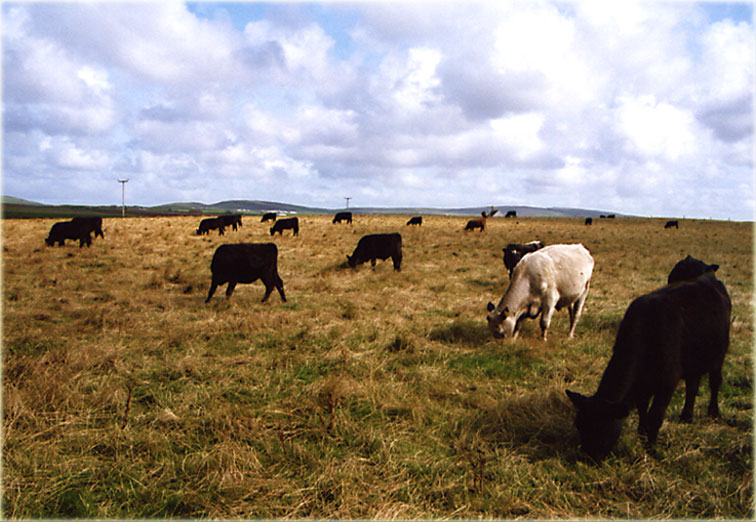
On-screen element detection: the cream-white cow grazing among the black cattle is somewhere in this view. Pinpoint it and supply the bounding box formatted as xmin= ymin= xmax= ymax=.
xmin=487 ymin=244 xmax=593 ymax=341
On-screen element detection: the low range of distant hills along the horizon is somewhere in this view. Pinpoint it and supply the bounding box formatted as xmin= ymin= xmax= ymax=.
xmin=2 ymin=196 xmax=619 ymax=218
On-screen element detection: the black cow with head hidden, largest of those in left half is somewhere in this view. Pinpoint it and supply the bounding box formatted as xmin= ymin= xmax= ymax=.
xmin=205 ymin=243 xmax=286 ymax=303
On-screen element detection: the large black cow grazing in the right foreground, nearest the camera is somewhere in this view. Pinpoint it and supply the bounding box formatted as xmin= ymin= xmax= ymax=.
xmin=567 ymin=264 xmax=731 ymax=461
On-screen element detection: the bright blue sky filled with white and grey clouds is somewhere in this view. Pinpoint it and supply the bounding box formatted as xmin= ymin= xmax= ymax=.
xmin=2 ymin=0 xmax=756 ymax=220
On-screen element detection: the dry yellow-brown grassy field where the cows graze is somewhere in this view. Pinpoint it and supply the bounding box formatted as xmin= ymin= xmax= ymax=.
xmin=2 ymin=212 xmax=754 ymax=519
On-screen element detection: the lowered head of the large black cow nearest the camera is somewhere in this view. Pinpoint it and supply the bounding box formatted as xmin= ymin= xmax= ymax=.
xmin=567 ymin=390 xmax=630 ymax=462
